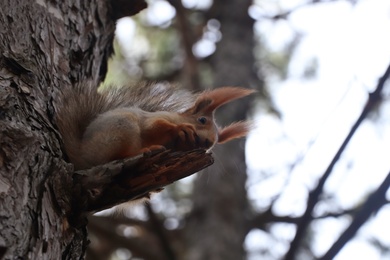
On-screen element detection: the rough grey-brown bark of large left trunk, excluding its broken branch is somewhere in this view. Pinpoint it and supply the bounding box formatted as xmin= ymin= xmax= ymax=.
xmin=0 ymin=1 xmax=114 ymax=259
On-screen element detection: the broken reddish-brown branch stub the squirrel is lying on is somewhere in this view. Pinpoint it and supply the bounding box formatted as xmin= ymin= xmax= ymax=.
xmin=69 ymin=149 xmax=214 ymax=226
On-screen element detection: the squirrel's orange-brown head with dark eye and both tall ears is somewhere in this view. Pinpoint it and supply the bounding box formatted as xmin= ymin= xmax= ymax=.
xmin=183 ymin=87 xmax=255 ymax=149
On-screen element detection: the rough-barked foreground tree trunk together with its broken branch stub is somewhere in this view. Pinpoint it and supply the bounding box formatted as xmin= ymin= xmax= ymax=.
xmin=0 ymin=0 xmax=212 ymax=259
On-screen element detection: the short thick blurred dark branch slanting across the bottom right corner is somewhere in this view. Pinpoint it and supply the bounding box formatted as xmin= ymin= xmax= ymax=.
xmin=320 ymin=172 xmax=390 ymax=260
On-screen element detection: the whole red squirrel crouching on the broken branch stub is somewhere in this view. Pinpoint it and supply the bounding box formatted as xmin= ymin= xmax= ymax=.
xmin=56 ymin=83 xmax=254 ymax=170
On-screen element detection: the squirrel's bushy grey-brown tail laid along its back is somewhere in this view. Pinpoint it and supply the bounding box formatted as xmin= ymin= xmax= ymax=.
xmin=55 ymin=80 xmax=196 ymax=169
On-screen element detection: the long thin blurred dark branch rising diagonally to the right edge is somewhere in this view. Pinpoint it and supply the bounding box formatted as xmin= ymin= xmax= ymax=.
xmin=285 ymin=65 xmax=390 ymax=260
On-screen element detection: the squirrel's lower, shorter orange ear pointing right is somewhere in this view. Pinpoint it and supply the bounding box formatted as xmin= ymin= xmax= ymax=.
xmin=218 ymin=121 xmax=254 ymax=144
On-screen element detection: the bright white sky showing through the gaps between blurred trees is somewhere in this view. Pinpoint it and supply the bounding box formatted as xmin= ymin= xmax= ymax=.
xmin=117 ymin=0 xmax=390 ymax=260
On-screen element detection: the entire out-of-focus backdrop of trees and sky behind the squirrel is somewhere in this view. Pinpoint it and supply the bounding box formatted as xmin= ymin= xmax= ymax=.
xmin=87 ymin=0 xmax=390 ymax=260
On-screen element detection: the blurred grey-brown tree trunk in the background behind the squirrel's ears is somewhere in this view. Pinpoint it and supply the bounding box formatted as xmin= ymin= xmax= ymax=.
xmin=187 ymin=0 xmax=262 ymax=260
